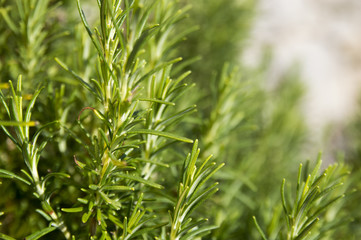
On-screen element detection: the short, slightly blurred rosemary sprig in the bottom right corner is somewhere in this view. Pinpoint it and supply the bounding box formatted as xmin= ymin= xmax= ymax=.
xmin=254 ymin=158 xmax=349 ymax=239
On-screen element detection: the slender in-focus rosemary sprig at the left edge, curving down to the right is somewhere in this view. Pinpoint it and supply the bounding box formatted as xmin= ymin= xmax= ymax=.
xmin=0 ymin=75 xmax=70 ymax=239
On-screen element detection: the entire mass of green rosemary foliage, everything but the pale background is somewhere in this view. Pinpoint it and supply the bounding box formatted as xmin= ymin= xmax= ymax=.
xmin=0 ymin=0 xmax=361 ymax=240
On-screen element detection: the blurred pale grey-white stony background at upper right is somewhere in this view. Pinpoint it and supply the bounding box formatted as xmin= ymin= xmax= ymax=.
xmin=242 ymin=0 xmax=361 ymax=154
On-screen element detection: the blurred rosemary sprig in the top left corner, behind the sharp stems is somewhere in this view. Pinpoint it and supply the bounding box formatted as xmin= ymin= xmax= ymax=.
xmin=0 ymin=0 xmax=64 ymax=83
